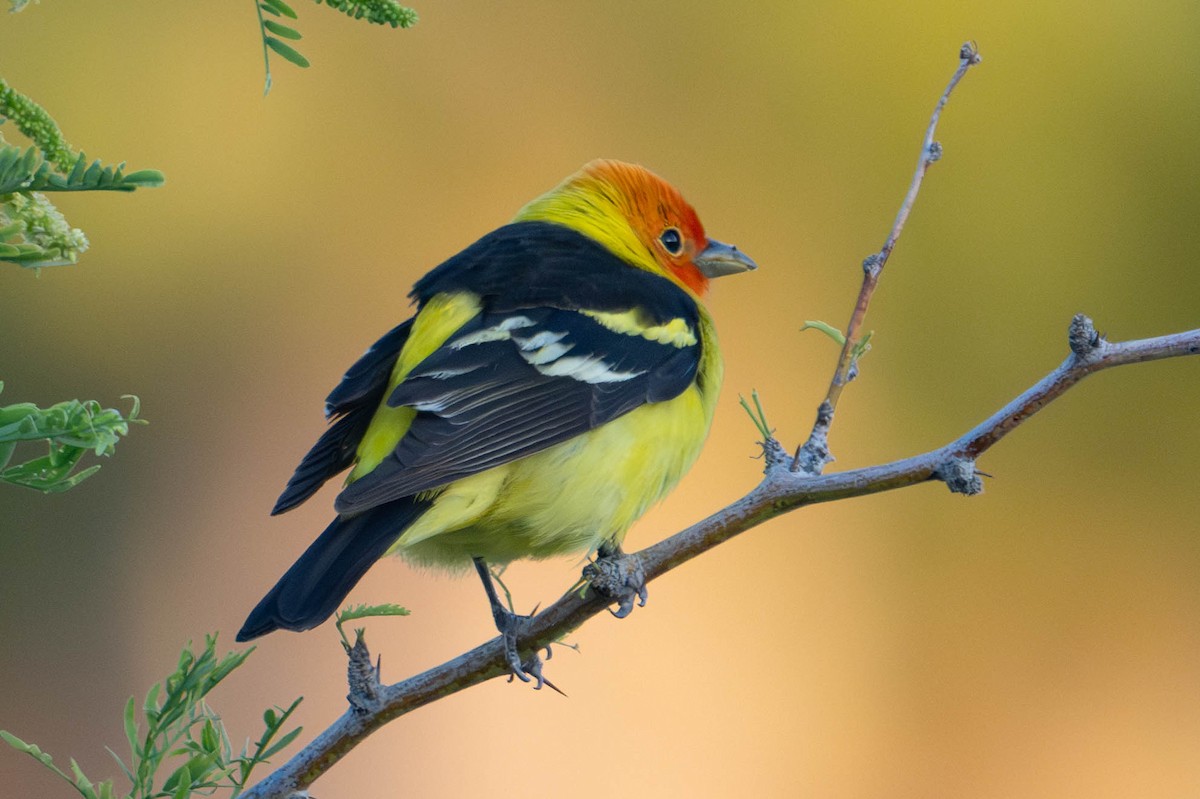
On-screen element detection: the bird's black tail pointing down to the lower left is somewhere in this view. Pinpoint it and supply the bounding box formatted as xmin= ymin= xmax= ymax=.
xmin=238 ymin=498 xmax=430 ymax=641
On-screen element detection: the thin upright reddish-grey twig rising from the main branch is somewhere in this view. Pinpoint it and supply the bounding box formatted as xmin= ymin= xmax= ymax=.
xmin=792 ymin=42 xmax=983 ymax=474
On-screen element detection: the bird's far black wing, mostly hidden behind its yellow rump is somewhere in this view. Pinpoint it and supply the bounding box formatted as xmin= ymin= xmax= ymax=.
xmin=271 ymin=319 xmax=413 ymax=516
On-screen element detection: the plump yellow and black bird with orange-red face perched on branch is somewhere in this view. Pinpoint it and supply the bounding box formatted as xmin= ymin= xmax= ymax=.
xmin=238 ymin=160 xmax=756 ymax=686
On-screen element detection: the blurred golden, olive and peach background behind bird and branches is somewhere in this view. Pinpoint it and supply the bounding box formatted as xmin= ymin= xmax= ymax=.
xmin=0 ymin=0 xmax=1200 ymax=799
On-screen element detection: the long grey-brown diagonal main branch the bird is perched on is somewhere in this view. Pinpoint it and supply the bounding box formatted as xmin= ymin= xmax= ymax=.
xmin=242 ymin=314 xmax=1200 ymax=799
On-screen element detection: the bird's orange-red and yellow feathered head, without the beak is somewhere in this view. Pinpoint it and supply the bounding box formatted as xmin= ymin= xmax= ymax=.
xmin=514 ymin=158 xmax=709 ymax=296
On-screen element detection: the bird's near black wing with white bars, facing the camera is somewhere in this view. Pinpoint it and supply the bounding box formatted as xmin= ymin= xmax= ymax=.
xmin=335 ymin=302 xmax=701 ymax=513
